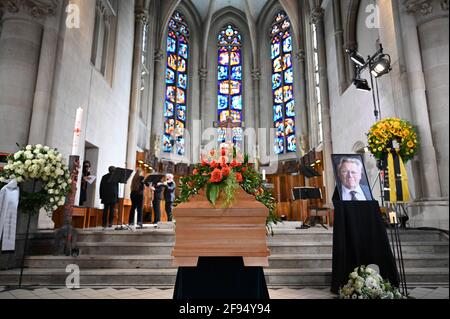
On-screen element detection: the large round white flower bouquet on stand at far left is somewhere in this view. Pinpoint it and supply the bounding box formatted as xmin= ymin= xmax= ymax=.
xmin=0 ymin=145 xmax=72 ymax=213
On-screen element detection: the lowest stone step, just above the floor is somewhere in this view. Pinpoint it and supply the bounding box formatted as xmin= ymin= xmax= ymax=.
xmin=0 ymin=268 xmax=448 ymax=287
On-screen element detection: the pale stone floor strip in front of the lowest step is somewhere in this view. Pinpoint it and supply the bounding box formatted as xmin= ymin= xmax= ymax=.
xmin=0 ymin=287 xmax=449 ymax=300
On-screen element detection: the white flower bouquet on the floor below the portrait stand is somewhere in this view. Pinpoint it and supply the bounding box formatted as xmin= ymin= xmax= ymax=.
xmin=339 ymin=266 xmax=405 ymax=299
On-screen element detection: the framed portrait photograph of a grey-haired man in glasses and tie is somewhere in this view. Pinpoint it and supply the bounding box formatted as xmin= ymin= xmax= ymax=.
xmin=331 ymin=154 xmax=374 ymax=201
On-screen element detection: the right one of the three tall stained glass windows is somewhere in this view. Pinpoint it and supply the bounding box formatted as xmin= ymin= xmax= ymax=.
xmin=270 ymin=11 xmax=297 ymax=155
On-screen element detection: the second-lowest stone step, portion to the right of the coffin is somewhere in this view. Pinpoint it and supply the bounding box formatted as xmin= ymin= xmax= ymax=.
xmin=269 ymin=254 xmax=449 ymax=269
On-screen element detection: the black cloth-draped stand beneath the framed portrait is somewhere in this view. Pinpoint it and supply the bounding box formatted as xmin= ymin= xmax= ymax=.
xmin=331 ymin=201 xmax=399 ymax=293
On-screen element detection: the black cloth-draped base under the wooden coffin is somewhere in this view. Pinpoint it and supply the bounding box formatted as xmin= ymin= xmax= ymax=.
xmin=173 ymin=257 xmax=270 ymax=300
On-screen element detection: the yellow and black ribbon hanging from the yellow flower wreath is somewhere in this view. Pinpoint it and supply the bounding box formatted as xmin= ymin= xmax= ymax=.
xmin=384 ymin=149 xmax=409 ymax=203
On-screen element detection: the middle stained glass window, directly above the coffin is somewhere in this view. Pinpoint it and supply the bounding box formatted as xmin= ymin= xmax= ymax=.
xmin=217 ymin=24 xmax=243 ymax=149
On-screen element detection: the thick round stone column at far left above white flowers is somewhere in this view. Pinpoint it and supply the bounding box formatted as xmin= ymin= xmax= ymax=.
xmin=0 ymin=0 xmax=57 ymax=152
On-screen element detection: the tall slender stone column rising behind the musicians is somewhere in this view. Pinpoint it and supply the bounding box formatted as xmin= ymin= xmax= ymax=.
xmin=127 ymin=7 xmax=148 ymax=180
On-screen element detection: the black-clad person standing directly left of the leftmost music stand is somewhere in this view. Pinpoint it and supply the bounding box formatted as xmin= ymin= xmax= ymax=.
xmin=100 ymin=166 xmax=119 ymax=228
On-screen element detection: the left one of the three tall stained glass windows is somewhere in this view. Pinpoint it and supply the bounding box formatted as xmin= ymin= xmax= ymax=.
xmin=163 ymin=11 xmax=189 ymax=155
